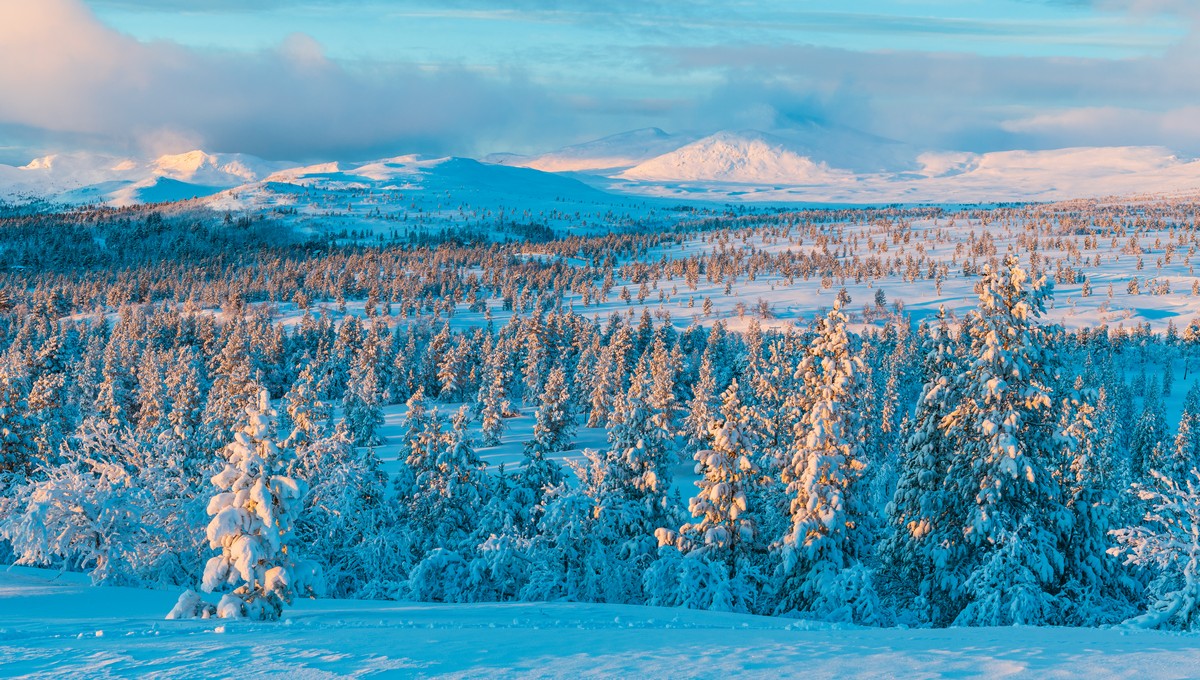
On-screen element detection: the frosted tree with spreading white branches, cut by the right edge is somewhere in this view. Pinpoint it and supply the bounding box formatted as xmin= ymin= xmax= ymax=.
xmin=1111 ymin=470 xmax=1200 ymax=631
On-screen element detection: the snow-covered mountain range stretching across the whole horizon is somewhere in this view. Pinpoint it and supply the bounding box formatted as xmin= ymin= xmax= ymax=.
xmin=0 ymin=124 xmax=1200 ymax=207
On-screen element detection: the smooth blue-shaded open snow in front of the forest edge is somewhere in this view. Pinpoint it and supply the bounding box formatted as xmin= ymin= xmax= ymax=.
xmin=0 ymin=567 xmax=1200 ymax=679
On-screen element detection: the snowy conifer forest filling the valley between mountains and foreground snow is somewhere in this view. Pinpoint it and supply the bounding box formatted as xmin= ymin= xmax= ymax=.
xmin=0 ymin=201 xmax=1200 ymax=630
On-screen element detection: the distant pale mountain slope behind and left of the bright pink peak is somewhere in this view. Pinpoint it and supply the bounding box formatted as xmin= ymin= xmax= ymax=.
xmin=484 ymin=127 xmax=696 ymax=173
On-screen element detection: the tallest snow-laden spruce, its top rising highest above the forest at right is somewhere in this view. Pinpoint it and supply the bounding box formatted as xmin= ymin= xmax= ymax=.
xmin=941 ymin=255 xmax=1070 ymax=626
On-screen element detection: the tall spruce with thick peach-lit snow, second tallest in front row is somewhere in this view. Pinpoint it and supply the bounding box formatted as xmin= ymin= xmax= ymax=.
xmin=775 ymin=305 xmax=881 ymax=624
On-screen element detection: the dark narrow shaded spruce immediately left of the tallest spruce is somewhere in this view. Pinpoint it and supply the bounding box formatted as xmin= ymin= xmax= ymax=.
xmin=882 ymin=308 xmax=967 ymax=626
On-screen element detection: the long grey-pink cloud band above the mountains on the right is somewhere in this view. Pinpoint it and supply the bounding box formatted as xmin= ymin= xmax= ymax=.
xmin=647 ymin=36 xmax=1200 ymax=152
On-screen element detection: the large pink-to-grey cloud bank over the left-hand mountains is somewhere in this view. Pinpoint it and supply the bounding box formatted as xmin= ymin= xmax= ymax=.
xmin=0 ymin=0 xmax=563 ymax=160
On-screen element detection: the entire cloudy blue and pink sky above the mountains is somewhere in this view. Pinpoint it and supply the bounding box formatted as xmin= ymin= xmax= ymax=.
xmin=0 ymin=0 xmax=1200 ymax=163
